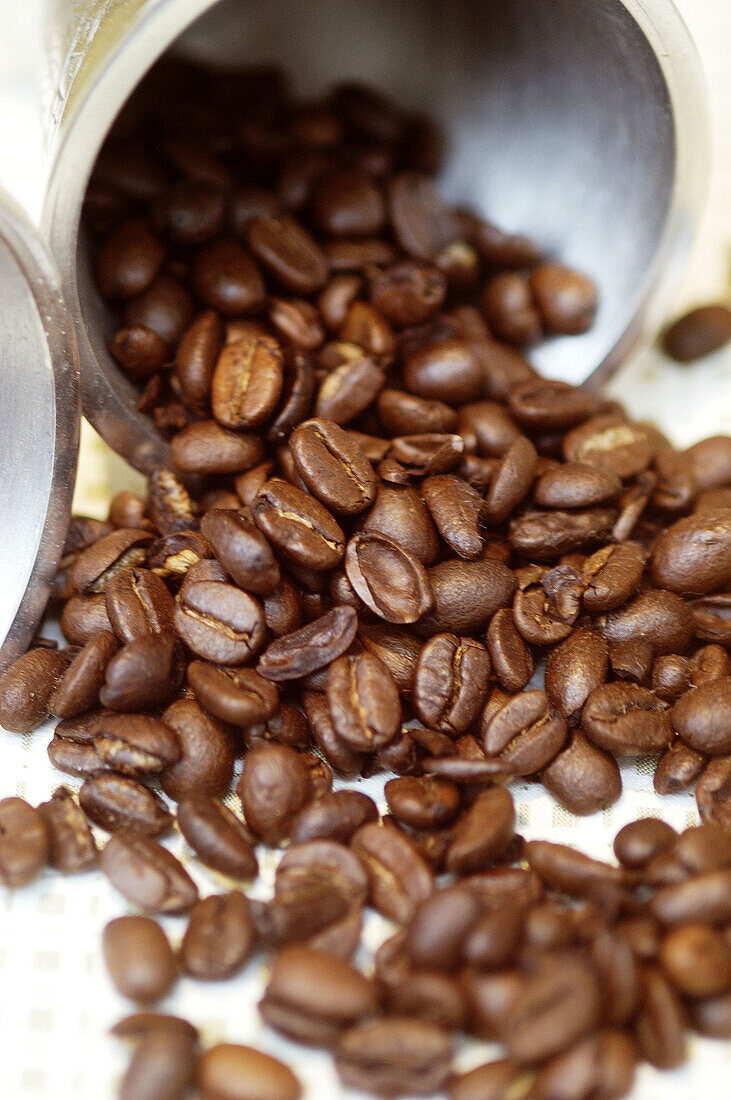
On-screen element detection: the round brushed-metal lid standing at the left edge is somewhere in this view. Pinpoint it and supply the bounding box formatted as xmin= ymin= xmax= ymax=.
xmin=0 ymin=193 xmax=80 ymax=672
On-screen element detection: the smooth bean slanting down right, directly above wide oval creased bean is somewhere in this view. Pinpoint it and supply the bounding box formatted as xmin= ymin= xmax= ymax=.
xmin=200 ymin=508 xmax=281 ymax=595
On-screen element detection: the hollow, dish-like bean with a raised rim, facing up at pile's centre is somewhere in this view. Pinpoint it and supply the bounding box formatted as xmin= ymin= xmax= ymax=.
xmin=345 ymin=531 xmax=432 ymax=624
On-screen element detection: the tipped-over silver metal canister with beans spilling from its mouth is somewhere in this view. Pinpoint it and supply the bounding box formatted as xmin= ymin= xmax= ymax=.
xmin=0 ymin=0 xmax=707 ymax=663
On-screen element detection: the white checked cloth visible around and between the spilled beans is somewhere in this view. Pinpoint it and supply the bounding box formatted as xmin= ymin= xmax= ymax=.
xmin=0 ymin=0 xmax=731 ymax=1100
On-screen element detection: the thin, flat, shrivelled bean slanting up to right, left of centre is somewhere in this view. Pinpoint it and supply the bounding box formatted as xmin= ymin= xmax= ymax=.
xmin=257 ymin=607 xmax=357 ymax=682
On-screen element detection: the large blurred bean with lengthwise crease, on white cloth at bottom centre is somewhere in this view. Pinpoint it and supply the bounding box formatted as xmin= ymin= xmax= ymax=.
xmin=259 ymin=947 xmax=377 ymax=1046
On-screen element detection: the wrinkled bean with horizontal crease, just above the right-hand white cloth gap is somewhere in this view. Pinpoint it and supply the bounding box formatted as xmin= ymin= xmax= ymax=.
xmin=582 ymin=683 xmax=673 ymax=756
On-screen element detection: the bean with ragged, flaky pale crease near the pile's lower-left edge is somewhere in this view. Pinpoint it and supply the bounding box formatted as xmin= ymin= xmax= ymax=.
xmin=93 ymin=713 xmax=180 ymax=777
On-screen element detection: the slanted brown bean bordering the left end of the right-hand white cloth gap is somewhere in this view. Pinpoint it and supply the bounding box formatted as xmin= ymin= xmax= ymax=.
xmin=446 ymin=787 xmax=516 ymax=875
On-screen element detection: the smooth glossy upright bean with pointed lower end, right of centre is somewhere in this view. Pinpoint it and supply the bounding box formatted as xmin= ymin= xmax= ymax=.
xmin=545 ymin=627 xmax=609 ymax=725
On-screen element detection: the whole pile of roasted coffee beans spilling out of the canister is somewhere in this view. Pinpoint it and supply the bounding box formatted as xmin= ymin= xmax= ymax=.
xmin=0 ymin=65 xmax=731 ymax=1100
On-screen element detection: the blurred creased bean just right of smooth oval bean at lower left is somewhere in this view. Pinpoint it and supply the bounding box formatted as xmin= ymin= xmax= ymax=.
xmin=180 ymin=890 xmax=255 ymax=981
